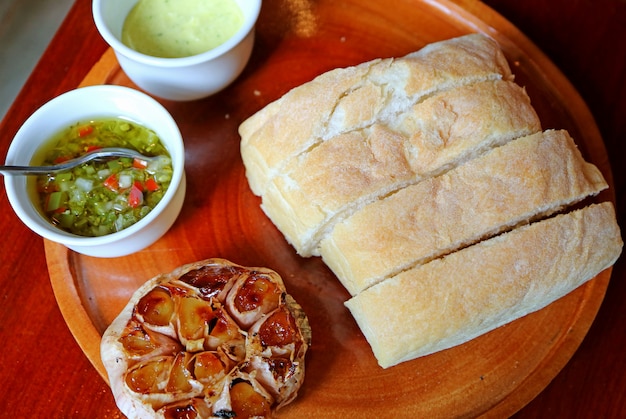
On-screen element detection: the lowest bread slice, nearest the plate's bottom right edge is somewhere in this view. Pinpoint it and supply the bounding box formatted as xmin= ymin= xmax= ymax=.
xmin=346 ymin=202 xmax=623 ymax=368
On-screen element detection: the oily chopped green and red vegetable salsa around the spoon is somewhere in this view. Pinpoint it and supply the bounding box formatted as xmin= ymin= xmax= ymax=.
xmin=36 ymin=119 xmax=172 ymax=237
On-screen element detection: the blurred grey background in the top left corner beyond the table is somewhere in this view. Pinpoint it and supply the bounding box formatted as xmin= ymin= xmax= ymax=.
xmin=0 ymin=0 xmax=74 ymax=120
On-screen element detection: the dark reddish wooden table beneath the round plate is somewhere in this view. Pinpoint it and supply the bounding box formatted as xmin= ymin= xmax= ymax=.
xmin=0 ymin=0 xmax=626 ymax=418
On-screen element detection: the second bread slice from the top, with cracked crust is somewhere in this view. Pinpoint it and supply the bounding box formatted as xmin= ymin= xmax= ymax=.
xmin=262 ymin=80 xmax=541 ymax=256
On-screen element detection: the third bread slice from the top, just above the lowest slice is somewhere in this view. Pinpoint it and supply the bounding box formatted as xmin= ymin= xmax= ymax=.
xmin=321 ymin=130 xmax=608 ymax=295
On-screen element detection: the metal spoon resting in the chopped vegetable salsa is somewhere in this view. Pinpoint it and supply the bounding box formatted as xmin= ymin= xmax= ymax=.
xmin=0 ymin=147 xmax=154 ymax=176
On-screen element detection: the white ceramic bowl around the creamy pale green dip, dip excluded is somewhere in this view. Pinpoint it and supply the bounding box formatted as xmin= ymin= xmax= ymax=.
xmin=92 ymin=0 xmax=261 ymax=101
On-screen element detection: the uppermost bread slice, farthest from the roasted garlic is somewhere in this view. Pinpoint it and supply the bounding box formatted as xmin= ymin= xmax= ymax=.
xmin=239 ymin=34 xmax=513 ymax=195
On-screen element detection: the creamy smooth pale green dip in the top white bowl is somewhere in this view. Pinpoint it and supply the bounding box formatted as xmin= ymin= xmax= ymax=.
xmin=122 ymin=0 xmax=243 ymax=58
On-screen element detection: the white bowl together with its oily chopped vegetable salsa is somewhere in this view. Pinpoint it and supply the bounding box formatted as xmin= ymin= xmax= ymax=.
xmin=5 ymin=86 xmax=186 ymax=257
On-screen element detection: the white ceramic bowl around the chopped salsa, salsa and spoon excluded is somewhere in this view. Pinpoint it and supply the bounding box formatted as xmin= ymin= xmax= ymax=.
xmin=5 ymin=86 xmax=186 ymax=257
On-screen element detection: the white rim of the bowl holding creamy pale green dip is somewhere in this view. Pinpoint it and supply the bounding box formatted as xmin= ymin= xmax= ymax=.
xmin=92 ymin=0 xmax=262 ymax=68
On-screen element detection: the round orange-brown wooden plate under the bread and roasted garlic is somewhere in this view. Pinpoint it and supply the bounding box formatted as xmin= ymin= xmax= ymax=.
xmin=45 ymin=0 xmax=613 ymax=418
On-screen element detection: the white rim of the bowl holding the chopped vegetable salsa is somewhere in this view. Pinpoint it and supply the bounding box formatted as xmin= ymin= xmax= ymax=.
xmin=5 ymin=85 xmax=185 ymax=247
